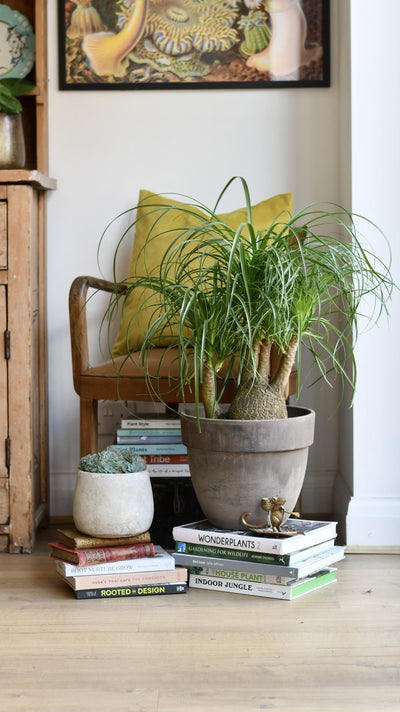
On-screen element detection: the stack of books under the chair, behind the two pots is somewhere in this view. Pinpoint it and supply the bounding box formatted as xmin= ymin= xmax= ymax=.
xmin=116 ymin=416 xmax=190 ymax=477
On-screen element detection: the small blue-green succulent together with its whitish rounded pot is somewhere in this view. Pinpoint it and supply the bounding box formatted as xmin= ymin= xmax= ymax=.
xmin=73 ymin=446 xmax=154 ymax=538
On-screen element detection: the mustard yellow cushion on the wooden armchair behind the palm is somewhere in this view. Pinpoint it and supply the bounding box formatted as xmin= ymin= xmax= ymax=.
xmin=113 ymin=190 xmax=293 ymax=357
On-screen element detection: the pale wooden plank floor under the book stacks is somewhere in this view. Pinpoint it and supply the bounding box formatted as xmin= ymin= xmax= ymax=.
xmin=0 ymin=531 xmax=400 ymax=712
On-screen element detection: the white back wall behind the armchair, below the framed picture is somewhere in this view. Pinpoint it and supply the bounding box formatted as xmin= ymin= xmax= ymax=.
xmin=48 ymin=0 xmax=396 ymax=532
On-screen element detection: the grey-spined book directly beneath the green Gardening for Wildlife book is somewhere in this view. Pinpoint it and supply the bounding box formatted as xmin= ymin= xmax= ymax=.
xmin=172 ymin=546 xmax=344 ymax=580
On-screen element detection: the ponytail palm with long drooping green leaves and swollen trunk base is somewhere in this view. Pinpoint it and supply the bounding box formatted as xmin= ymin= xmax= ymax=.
xmin=101 ymin=178 xmax=393 ymax=420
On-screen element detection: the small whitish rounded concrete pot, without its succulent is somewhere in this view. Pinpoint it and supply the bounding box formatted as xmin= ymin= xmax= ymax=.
xmin=72 ymin=470 xmax=154 ymax=538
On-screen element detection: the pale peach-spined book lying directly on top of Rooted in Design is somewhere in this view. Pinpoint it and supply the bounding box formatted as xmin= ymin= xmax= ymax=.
xmin=56 ymin=568 xmax=188 ymax=591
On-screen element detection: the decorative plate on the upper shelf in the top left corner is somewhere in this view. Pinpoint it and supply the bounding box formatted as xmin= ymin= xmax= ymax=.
xmin=0 ymin=5 xmax=35 ymax=79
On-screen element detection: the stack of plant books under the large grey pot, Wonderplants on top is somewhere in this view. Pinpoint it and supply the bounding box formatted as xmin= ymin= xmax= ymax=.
xmin=172 ymin=519 xmax=344 ymax=600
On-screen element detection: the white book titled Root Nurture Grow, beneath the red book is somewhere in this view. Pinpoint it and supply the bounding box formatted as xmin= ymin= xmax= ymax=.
xmin=53 ymin=544 xmax=175 ymax=576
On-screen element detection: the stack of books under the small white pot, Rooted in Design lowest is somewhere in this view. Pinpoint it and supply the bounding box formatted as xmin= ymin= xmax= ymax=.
xmin=49 ymin=527 xmax=187 ymax=599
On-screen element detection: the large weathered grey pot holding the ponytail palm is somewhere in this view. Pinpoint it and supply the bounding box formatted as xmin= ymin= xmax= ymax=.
xmin=181 ymin=406 xmax=315 ymax=530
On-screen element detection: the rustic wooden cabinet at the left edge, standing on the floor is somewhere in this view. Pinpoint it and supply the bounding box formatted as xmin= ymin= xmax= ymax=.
xmin=0 ymin=170 xmax=56 ymax=553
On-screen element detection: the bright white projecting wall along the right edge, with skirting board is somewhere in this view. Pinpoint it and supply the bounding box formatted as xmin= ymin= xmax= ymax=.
xmin=340 ymin=0 xmax=400 ymax=547
